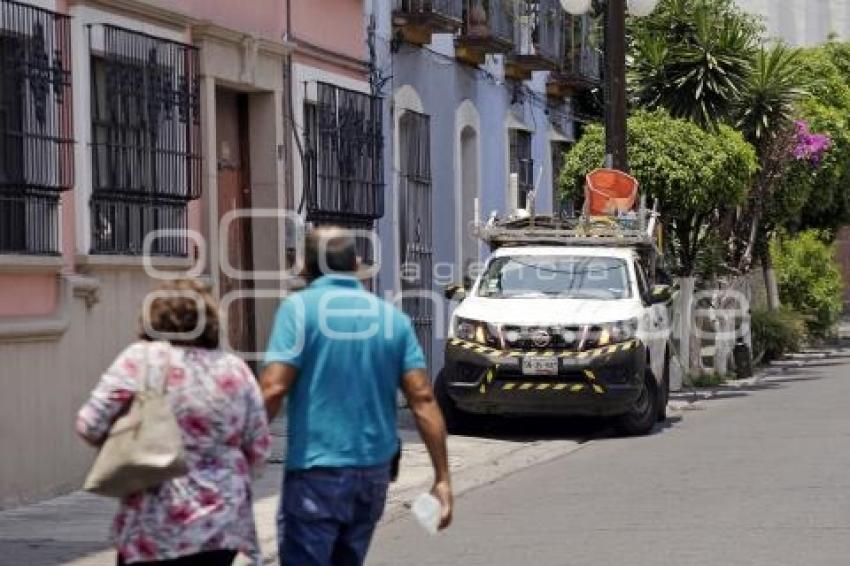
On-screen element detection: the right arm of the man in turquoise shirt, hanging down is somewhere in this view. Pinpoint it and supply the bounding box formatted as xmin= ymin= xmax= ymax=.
xmin=401 ymin=369 xmax=453 ymax=529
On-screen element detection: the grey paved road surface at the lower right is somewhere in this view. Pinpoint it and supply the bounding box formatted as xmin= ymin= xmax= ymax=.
xmin=369 ymin=352 xmax=850 ymax=566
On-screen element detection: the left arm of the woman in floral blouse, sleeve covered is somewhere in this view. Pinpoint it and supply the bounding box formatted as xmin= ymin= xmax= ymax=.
xmin=77 ymin=343 xmax=147 ymax=446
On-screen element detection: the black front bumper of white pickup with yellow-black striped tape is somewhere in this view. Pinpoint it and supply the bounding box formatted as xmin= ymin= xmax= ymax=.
xmin=442 ymin=339 xmax=646 ymax=416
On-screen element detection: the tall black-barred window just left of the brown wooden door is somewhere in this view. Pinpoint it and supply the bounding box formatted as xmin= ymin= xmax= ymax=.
xmin=90 ymin=25 xmax=201 ymax=256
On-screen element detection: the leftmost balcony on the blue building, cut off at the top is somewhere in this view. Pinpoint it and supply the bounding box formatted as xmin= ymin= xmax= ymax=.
xmin=393 ymin=0 xmax=463 ymax=45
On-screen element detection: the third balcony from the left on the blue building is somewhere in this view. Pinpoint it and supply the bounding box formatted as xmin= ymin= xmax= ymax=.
xmin=514 ymin=0 xmax=564 ymax=70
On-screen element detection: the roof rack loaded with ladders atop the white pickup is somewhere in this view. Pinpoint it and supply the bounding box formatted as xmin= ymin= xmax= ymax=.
xmin=473 ymin=199 xmax=660 ymax=251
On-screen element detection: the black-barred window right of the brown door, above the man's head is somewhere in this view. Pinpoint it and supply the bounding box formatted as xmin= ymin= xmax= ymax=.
xmin=303 ymin=83 xmax=384 ymax=221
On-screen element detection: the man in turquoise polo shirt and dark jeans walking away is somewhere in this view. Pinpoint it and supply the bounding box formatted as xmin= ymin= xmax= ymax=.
xmin=261 ymin=228 xmax=452 ymax=566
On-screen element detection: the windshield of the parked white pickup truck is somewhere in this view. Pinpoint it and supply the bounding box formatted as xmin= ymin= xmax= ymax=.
xmin=478 ymin=255 xmax=631 ymax=300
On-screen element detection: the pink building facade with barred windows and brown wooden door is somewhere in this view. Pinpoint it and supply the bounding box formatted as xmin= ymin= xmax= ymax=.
xmin=0 ymin=0 xmax=324 ymax=507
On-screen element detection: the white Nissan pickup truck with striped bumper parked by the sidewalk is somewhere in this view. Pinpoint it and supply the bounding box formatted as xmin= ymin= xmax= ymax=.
xmin=435 ymin=216 xmax=671 ymax=435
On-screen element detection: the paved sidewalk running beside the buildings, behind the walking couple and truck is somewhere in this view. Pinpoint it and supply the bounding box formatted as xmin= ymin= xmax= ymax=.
xmin=0 ymin=346 xmax=850 ymax=566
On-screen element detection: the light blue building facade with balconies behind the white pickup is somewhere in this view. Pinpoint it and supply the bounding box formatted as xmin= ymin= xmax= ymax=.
xmin=367 ymin=0 xmax=598 ymax=373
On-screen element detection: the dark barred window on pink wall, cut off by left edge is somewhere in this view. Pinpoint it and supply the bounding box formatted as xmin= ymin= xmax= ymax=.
xmin=0 ymin=0 xmax=74 ymax=255
